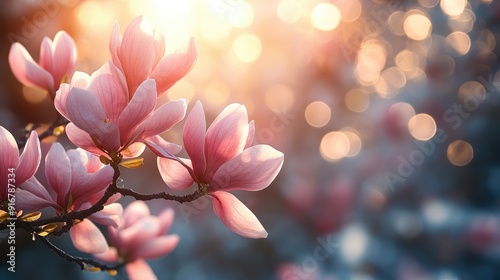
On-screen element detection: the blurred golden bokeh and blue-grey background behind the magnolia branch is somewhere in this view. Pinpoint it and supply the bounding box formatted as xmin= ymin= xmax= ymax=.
xmin=0 ymin=0 xmax=500 ymax=280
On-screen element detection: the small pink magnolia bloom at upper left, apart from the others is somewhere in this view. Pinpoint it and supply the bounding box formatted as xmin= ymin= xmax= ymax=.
xmin=9 ymin=31 xmax=76 ymax=99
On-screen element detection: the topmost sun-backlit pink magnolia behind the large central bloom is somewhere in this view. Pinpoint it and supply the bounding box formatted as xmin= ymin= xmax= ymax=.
xmin=109 ymin=16 xmax=198 ymax=95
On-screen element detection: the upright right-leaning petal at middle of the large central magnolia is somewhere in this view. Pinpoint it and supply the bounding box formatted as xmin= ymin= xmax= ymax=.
xmin=118 ymin=79 xmax=156 ymax=144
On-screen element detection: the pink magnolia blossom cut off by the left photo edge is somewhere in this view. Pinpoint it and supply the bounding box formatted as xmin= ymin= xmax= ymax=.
xmin=0 ymin=126 xmax=41 ymax=201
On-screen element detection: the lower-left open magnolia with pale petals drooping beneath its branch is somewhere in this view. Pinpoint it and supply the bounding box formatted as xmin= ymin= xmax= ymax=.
xmin=16 ymin=143 xmax=123 ymax=253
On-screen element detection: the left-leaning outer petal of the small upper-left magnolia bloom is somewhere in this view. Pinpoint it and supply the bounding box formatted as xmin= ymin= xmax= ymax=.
xmin=9 ymin=42 xmax=54 ymax=92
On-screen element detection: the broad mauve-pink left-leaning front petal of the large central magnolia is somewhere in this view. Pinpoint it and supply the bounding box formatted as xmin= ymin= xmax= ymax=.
xmin=66 ymin=88 xmax=120 ymax=152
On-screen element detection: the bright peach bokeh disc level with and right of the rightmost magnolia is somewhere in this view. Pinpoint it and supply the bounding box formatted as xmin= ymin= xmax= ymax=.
xmin=319 ymin=131 xmax=351 ymax=162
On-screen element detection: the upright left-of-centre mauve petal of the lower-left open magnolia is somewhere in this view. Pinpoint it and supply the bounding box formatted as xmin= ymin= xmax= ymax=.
xmin=45 ymin=142 xmax=71 ymax=208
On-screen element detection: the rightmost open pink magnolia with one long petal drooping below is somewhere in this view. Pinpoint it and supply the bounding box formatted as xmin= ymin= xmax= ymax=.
xmin=158 ymin=102 xmax=283 ymax=238
